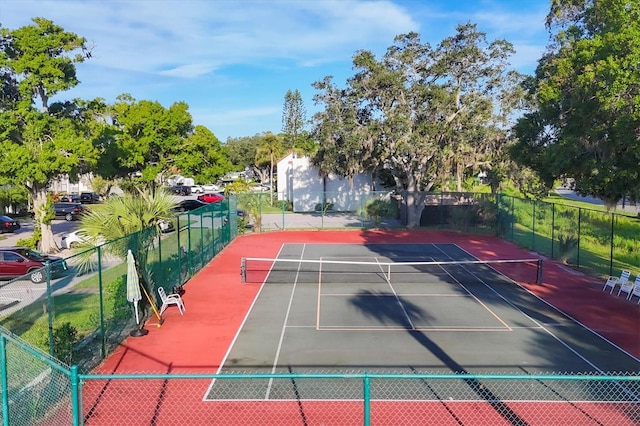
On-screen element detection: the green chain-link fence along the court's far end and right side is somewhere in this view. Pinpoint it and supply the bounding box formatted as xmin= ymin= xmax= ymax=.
xmin=239 ymin=192 xmax=640 ymax=276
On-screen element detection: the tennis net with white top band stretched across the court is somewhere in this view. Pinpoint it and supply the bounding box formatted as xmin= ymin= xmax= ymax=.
xmin=240 ymin=257 xmax=542 ymax=284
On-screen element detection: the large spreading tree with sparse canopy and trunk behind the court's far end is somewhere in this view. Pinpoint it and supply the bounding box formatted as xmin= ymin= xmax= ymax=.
xmin=314 ymin=24 xmax=516 ymax=226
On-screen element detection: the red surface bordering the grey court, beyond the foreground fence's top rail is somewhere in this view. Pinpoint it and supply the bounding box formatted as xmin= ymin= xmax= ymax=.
xmin=97 ymin=230 xmax=640 ymax=373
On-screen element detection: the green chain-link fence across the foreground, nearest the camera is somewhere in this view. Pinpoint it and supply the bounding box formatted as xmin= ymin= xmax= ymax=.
xmin=0 ymin=328 xmax=640 ymax=426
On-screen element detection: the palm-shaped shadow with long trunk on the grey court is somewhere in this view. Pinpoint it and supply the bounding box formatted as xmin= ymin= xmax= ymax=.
xmin=350 ymin=290 xmax=528 ymax=425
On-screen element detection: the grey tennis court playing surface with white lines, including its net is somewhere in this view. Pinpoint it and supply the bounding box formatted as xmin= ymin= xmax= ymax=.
xmin=205 ymin=243 xmax=640 ymax=401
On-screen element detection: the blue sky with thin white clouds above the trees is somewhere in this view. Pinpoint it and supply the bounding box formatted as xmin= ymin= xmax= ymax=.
xmin=0 ymin=0 xmax=549 ymax=142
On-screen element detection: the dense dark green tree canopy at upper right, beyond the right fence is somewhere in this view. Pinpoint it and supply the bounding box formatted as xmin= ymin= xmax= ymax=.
xmin=513 ymin=0 xmax=640 ymax=205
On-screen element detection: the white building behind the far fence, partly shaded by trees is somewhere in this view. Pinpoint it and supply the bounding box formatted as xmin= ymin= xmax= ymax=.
xmin=277 ymin=153 xmax=373 ymax=212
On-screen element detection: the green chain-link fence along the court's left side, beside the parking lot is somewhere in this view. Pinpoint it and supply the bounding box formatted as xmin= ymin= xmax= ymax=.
xmin=0 ymin=197 xmax=238 ymax=372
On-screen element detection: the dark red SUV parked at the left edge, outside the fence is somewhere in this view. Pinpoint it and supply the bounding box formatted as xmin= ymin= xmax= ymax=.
xmin=0 ymin=247 xmax=68 ymax=283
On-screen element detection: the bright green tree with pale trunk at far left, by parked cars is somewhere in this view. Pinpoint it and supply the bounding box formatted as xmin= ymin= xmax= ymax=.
xmin=0 ymin=18 xmax=97 ymax=252
